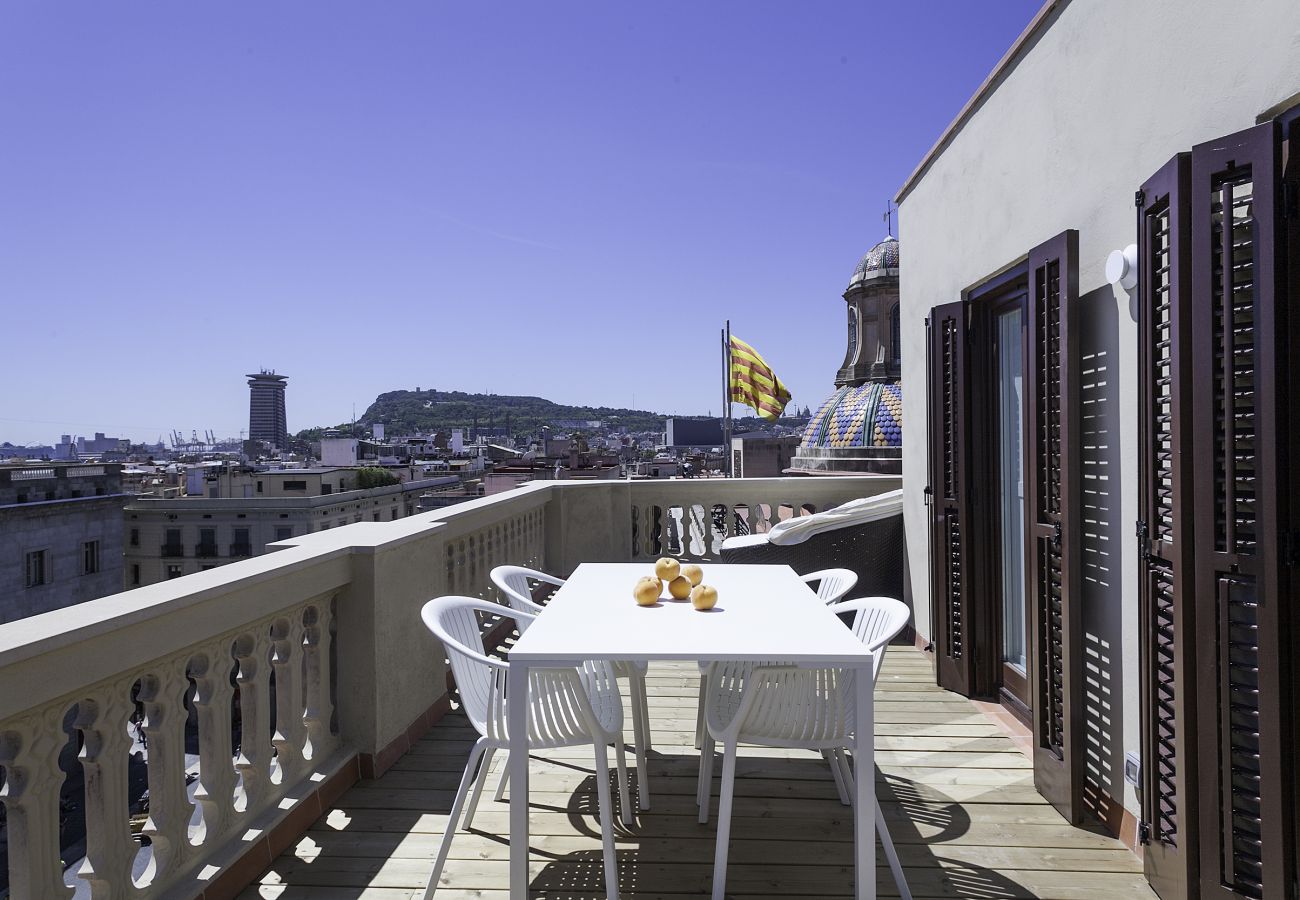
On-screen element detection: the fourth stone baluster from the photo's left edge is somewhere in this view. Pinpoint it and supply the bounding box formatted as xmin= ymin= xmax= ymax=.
xmin=190 ymin=641 xmax=237 ymax=845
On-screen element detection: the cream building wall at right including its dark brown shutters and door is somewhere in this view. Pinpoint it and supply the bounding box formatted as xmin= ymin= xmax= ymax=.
xmin=898 ymin=0 xmax=1300 ymax=900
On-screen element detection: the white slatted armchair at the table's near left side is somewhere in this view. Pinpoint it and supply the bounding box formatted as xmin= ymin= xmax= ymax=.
xmin=420 ymin=597 xmax=632 ymax=900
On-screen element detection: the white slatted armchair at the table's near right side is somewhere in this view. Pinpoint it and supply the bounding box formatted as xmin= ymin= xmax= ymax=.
xmin=697 ymin=597 xmax=911 ymax=900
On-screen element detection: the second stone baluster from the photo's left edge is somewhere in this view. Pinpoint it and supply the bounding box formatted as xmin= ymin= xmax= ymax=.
xmin=74 ymin=679 xmax=139 ymax=900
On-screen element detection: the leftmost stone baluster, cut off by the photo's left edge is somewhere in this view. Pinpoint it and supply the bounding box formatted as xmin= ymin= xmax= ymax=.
xmin=0 ymin=709 xmax=73 ymax=900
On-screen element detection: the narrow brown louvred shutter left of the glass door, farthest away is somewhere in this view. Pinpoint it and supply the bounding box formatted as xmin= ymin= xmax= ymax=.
xmin=927 ymin=302 xmax=975 ymax=696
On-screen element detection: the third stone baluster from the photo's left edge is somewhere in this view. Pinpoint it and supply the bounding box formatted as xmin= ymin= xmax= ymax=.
xmin=139 ymin=661 xmax=194 ymax=878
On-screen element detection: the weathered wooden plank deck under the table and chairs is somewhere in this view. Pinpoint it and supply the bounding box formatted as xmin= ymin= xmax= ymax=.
xmin=241 ymin=648 xmax=1156 ymax=900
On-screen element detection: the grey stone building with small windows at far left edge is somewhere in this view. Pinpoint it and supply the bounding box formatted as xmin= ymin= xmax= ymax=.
xmin=0 ymin=463 xmax=126 ymax=624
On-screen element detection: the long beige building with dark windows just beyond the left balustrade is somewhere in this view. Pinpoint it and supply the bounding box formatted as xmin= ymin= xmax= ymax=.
xmin=118 ymin=468 xmax=449 ymax=588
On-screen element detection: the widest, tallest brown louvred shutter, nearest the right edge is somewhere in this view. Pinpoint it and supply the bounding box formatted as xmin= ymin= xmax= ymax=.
xmin=1191 ymin=122 xmax=1300 ymax=899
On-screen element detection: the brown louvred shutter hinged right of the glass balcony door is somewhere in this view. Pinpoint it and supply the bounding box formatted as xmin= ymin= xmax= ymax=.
xmin=1026 ymin=230 xmax=1083 ymax=822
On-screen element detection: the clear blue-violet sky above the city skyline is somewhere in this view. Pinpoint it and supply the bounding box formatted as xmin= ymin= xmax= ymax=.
xmin=0 ymin=0 xmax=1040 ymax=442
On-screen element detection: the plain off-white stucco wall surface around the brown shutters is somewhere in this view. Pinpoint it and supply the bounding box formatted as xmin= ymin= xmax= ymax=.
xmin=900 ymin=0 xmax=1300 ymax=810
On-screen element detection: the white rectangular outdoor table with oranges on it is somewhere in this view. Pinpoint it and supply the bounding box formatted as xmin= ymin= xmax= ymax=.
xmin=507 ymin=563 xmax=876 ymax=900
